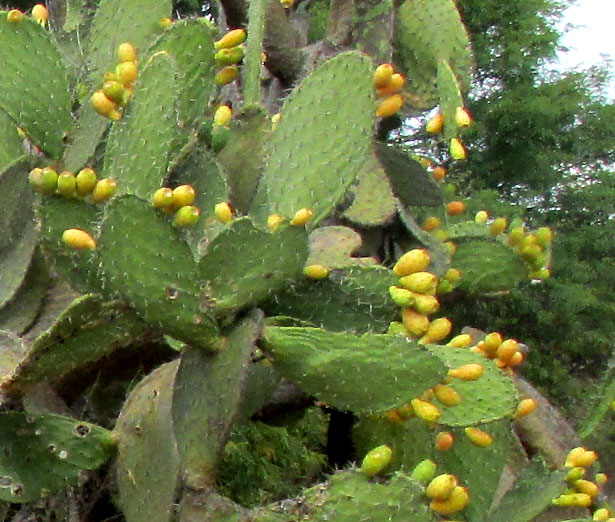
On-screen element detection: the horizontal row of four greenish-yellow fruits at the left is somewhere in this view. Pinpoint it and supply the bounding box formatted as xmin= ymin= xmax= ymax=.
xmin=28 ymin=167 xmax=117 ymax=203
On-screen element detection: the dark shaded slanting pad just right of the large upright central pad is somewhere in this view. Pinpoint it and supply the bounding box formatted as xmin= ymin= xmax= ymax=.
xmin=376 ymin=144 xmax=444 ymax=207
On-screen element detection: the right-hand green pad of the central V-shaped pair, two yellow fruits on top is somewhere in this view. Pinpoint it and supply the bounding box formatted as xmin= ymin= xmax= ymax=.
xmin=199 ymin=218 xmax=307 ymax=311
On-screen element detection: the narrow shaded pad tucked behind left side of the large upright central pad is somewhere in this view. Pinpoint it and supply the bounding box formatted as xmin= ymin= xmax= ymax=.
xmin=218 ymin=109 xmax=271 ymax=213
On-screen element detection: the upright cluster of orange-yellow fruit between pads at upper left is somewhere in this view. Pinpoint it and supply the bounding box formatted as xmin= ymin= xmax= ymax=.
xmin=91 ymin=42 xmax=139 ymax=121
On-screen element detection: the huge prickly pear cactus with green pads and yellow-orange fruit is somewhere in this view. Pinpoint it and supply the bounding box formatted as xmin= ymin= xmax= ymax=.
xmin=0 ymin=0 xmax=595 ymax=522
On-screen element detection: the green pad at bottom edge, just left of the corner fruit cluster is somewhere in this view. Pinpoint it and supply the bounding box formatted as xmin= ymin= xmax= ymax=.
xmin=489 ymin=460 xmax=566 ymax=522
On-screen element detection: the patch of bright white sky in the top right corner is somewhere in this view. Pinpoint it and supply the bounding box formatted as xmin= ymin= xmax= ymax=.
xmin=559 ymin=0 xmax=615 ymax=99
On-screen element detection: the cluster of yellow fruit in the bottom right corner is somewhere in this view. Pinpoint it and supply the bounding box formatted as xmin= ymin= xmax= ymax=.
xmin=552 ymin=447 xmax=615 ymax=512
